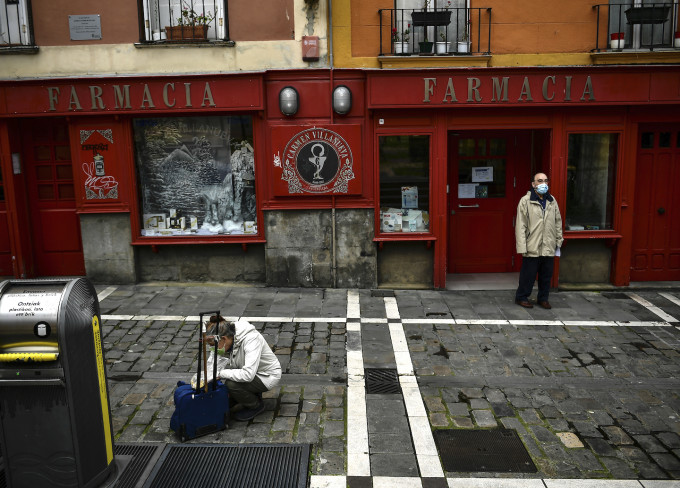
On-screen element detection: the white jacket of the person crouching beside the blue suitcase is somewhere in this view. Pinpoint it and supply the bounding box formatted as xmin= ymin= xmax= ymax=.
xmin=214 ymin=320 xmax=281 ymax=390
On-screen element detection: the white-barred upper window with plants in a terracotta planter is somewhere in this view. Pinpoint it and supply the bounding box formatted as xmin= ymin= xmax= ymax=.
xmin=138 ymin=0 xmax=229 ymax=43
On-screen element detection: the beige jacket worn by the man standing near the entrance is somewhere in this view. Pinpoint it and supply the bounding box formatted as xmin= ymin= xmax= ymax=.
xmin=515 ymin=191 xmax=564 ymax=258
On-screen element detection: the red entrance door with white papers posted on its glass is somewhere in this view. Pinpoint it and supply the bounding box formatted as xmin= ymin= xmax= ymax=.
xmin=447 ymin=132 xmax=531 ymax=273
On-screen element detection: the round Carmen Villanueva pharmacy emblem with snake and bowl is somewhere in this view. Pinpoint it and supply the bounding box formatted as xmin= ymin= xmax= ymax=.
xmin=281 ymin=127 xmax=355 ymax=193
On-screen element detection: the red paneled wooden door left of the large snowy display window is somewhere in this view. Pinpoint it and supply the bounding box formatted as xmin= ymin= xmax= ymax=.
xmin=22 ymin=119 xmax=85 ymax=276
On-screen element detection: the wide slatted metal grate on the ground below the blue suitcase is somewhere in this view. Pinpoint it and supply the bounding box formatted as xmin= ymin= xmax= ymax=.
xmin=144 ymin=444 xmax=310 ymax=488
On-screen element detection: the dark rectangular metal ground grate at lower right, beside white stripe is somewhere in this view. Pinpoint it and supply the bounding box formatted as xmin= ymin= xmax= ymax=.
xmin=433 ymin=429 xmax=537 ymax=473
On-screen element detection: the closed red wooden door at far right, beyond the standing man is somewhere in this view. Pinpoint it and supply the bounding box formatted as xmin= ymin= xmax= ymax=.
xmin=630 ymin=126 xmax=680 ymax=281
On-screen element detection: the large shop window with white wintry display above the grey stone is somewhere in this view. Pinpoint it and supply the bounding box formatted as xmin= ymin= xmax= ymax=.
xmin=133 ymin=116 xmax=257 ymax=236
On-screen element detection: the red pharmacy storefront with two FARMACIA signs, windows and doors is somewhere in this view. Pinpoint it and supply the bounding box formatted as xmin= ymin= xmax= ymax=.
xmin=0 ymin=66 xmax=680 ymax=288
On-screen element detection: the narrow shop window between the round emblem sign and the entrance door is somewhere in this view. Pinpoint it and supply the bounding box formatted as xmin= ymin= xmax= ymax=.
xmin=379 ymin=135 xmax=430 ymax=233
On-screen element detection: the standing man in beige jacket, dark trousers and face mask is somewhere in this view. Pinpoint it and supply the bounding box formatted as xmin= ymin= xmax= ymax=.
xmin=515 ymin=173 xmax=564 ymax=308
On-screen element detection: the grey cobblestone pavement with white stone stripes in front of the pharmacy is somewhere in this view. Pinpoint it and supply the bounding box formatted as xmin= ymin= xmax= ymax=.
xmin=97 ymin=284 xmax=680 ymax=488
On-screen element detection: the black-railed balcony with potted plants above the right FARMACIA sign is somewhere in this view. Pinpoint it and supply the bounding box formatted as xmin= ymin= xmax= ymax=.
xmin=378 ymin=7 xmax=491 ymax=56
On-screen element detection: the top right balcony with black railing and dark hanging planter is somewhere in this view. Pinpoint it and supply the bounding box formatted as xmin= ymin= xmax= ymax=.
xmin=593 ymin=0 xmax=680 ymax=52
